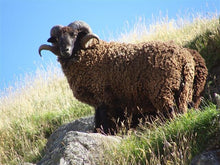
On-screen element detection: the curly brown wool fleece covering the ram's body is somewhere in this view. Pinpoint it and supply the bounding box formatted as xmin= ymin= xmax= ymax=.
xmin=58 ymin=41 xmax=198 ymax=113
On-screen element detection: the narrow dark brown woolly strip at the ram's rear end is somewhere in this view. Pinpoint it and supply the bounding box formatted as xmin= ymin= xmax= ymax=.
xmin=187 ymin=49 xmax=208 ymax=109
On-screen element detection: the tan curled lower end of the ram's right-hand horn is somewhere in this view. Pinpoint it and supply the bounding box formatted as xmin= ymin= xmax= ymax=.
xmin=81 ymin=33 xmax=99 ymax=49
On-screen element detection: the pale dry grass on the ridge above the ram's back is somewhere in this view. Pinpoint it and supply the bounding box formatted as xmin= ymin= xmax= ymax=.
xmin=118 ymin=14 xmax=219 ymax=45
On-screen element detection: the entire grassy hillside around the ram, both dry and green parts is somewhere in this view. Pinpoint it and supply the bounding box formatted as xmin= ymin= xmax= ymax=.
xmin=0 ymin=15 xmax=220 ymax=164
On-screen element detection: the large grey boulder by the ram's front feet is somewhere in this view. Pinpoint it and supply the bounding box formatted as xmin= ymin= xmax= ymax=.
xmin=37 ymin=117 xmax=121 ymax=165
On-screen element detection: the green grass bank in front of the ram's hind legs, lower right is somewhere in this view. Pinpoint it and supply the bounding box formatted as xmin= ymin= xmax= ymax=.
xmin=101 ymin=105 xmax=220 ymax=165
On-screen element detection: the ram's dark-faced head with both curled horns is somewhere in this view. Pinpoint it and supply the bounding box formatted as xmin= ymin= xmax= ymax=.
xmin=38 ymin=21 xmax=99 ymax=59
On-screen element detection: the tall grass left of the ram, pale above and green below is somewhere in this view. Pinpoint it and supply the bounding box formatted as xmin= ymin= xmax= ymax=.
xmin=0 ymin=65 xmax=93 ymax=164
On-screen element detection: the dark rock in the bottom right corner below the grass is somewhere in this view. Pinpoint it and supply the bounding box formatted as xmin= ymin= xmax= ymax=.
xmin=190 ymin=149 xmax=220 ymax=165
